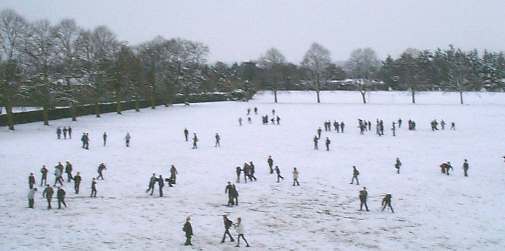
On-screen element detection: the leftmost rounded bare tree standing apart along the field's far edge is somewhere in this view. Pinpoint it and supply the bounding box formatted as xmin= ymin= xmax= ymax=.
xmin=258 ymin=48 xmax=286 ymax=103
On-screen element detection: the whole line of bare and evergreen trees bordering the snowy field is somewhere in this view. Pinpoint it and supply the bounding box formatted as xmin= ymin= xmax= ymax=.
xmin=0 ymin=9 xmax=505 ymax=129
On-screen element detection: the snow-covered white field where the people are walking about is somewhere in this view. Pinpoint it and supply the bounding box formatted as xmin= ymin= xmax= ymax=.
xmin=0 ymin=92 xmax=505 ymax=250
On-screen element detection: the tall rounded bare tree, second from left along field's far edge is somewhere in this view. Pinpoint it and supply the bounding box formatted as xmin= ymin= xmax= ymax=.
xmin=302 ymin=43 xmax=331 ymax=103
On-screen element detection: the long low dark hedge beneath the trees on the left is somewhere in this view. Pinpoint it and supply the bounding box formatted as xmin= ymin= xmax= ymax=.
xmin=0 ymin=92 xmax=250 ymax=126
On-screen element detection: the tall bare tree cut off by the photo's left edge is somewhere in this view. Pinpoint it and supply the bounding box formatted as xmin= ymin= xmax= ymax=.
xmin=0 ymin=9 xmax=27 ymax=130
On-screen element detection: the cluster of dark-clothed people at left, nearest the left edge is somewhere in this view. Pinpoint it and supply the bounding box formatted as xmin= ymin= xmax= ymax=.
xmin=28 ymin=161 xmax=107 ymax=209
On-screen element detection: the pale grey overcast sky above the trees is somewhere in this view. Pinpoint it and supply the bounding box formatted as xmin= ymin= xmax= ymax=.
xmin=0 ymin=0 xmax=505 ymax=63
